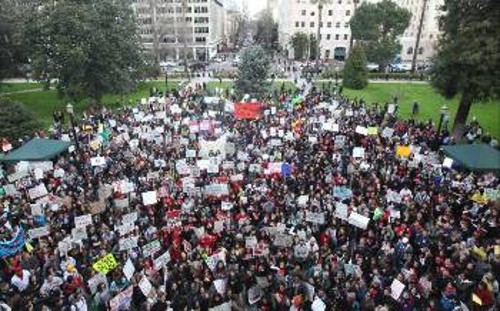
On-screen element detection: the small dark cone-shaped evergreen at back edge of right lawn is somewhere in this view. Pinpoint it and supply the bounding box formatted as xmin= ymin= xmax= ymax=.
xmin=342 ymin=44 xmax=368 ymax=90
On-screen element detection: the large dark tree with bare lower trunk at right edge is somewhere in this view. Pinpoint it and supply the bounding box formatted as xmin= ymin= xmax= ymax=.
xmin=430 ymin=0 xmax=500 ymax=140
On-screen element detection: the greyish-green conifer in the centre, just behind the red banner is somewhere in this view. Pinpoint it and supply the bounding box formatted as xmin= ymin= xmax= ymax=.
xmin=235 ymin=46 xmax=270 ymax=98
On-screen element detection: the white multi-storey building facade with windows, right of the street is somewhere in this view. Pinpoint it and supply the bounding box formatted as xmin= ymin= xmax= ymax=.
xmin=273 ymin=0 xmax=444 ymax=62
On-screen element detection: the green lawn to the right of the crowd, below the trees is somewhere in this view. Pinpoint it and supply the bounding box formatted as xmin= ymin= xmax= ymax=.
xmin=318 ymin=83 xmax=500 ymax=137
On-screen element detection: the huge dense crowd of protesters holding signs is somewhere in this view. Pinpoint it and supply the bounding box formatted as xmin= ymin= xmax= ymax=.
xmin=0 ymin=81 xmax=500 ymax=311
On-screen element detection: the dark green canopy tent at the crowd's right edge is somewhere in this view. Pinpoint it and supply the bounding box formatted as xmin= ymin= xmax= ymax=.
xmin=443 ymin=144 xmax=500 ymax=171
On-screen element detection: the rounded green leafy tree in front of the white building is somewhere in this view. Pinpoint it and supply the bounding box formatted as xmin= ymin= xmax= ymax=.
xmin=350 ymin=0 xmax=411 ymax=70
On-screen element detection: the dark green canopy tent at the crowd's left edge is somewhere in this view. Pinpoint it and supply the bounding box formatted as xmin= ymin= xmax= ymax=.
xmin=0 ymin=138 xmax=71 ymax=162
